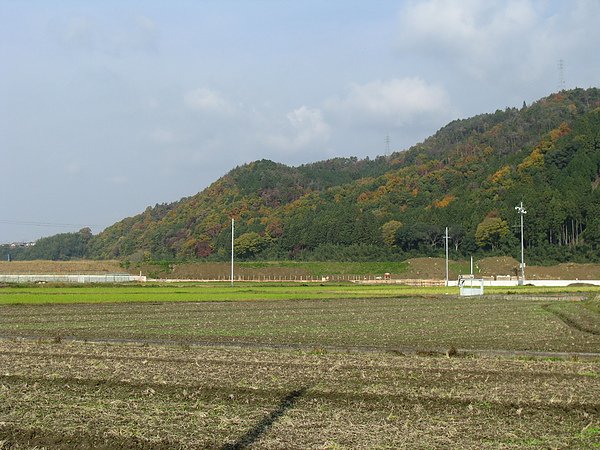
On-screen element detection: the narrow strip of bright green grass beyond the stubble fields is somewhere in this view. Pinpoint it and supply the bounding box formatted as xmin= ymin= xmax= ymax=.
xmin=0 ymin=282 xmax=600 ymax=305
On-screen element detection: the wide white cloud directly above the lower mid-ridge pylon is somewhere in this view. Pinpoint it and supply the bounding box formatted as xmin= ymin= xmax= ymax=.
xmin=326 ymin=77 xmax=450 ymax=127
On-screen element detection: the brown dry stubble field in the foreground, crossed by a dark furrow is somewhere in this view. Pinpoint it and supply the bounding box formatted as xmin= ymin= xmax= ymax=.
xmin=0 ymin=341 xmax=600 ymax=449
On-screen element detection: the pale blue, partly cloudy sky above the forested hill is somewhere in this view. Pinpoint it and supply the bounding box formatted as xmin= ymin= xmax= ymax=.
xmin=0 ymin=0 xmax=600 ymax=243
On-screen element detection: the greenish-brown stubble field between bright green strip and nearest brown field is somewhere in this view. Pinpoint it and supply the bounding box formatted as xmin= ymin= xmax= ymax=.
xmin=0 ymin=296 xmax=600 ymax=353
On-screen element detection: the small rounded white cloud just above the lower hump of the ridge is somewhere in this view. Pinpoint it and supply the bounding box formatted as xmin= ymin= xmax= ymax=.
xmin=264 ymin=106 xmax=330 ymax=152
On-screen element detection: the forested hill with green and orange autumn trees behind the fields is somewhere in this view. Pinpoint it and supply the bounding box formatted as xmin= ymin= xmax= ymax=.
xmin=8 ymin=88 xmax=600 ymax=262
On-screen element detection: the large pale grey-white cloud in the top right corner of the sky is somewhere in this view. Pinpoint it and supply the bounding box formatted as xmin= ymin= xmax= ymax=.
xmin=398 ymin=0 xmax=600 ymax=84
